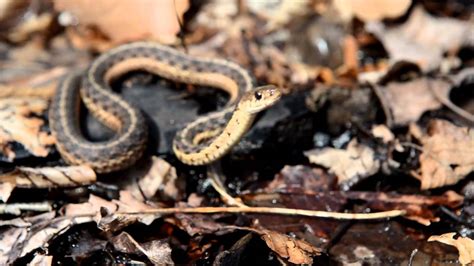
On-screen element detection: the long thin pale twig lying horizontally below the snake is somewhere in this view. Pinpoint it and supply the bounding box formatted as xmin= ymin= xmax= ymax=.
xmin=115 ymin=207 xmax=406 ymax=220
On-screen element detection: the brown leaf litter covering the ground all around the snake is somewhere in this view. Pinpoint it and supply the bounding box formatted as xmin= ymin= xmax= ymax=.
xmin=0 ymin=0 xmax=474 ymax=265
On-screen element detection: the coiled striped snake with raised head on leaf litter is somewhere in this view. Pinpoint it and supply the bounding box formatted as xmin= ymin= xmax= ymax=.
xmin=49 ymin=42 xmax=282 ymax=173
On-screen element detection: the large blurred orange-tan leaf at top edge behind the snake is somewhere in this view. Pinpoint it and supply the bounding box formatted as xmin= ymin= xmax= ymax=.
xmin=54 ymin=0 xmax=189 ymax=44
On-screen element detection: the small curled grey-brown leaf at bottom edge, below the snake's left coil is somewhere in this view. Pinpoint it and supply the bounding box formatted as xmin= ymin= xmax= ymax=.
xmin=112 ymin=232 xmax=174 ymax=265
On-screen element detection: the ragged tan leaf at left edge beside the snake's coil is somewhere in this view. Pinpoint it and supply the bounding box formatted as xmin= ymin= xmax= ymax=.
xmin=0 ymin=98 xmax=54 ymax=161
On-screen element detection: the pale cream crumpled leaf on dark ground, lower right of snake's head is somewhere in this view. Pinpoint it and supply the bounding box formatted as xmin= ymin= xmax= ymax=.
xmin=305 ymin=139 xmax=380 ymax=188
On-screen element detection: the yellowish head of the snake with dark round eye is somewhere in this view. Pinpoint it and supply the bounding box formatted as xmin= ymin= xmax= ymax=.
xmin=238 ymin=85 xmax=281 ymax=114
